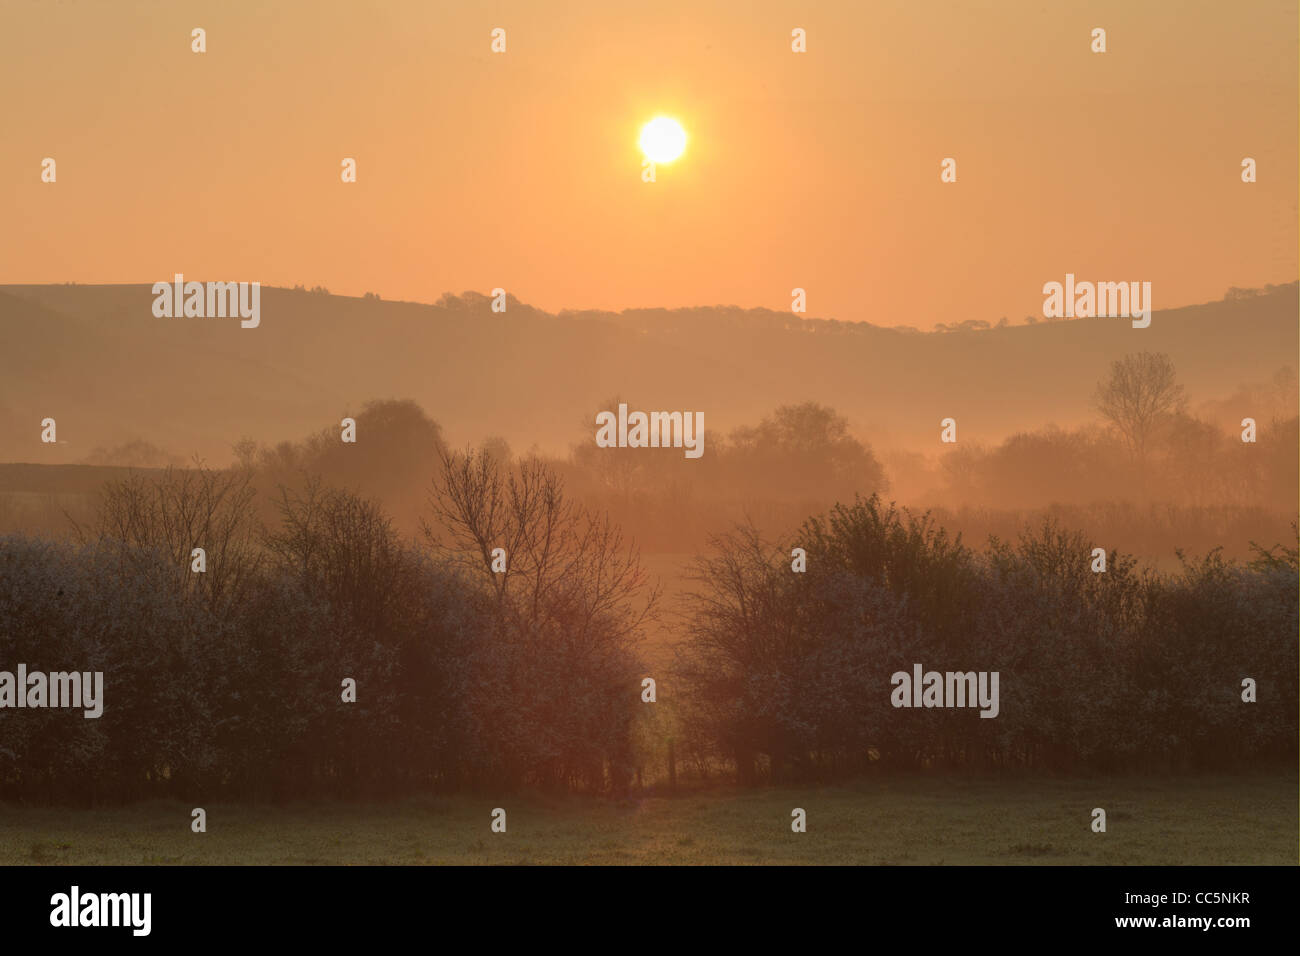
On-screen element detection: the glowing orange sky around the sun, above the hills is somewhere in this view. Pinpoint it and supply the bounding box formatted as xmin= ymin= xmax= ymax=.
xmin=0 ymin=0 xmax=1297 ymax=328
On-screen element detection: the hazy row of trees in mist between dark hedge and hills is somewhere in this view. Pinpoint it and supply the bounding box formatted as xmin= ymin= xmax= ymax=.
xmin=0 ymin=354 xmax=1300 ymax=566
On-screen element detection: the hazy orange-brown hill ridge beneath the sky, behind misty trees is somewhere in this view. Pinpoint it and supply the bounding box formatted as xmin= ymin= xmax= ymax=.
xmin=0 ymin=277 xmax=1300 ymax=464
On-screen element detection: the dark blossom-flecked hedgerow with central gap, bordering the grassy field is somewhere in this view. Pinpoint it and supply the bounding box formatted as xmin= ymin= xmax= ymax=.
xmin=0 ymin=449 xmax=1300 ymax=803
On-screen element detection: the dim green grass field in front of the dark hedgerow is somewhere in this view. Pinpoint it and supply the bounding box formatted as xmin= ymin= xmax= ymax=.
xmin=0 ymin=771 xmax=1297 ymax=865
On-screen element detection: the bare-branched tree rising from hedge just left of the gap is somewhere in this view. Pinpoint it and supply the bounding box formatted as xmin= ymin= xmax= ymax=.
xmin=425 ymin=449 xmax=658 ymax=792
